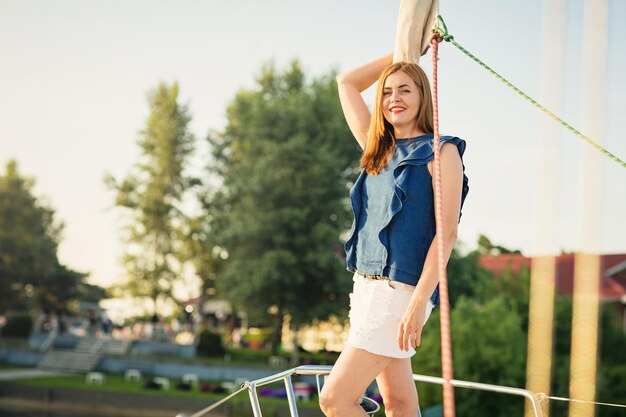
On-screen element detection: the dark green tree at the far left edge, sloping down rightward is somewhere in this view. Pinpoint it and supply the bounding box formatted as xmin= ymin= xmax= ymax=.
xmin=0 ymin=161 xmax=105 ymax=313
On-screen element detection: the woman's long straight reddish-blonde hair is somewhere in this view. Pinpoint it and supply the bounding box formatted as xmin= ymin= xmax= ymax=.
xmin=360 ymin=62 xmax=433 ymax=175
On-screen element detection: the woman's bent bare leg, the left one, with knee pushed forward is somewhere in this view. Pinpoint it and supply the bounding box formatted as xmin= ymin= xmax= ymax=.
xmin=320 ymin=345 xmax=392 ymax=417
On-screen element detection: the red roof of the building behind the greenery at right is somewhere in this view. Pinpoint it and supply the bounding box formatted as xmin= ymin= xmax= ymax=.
xmin=479 ymin=253 xmax=626 ymax=301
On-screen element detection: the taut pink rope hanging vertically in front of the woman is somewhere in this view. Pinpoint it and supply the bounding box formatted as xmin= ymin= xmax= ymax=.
xmin=430 ymin=38 xmax=455 ymax=417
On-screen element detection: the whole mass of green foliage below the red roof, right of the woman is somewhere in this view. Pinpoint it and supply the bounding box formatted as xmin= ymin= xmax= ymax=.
xmin=413 ymin=236 xmax=626 ymax=417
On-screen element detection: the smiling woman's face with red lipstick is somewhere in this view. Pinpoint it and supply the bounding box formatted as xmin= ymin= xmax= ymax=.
xmin=382 ymin=71 xmax=420 ymax=128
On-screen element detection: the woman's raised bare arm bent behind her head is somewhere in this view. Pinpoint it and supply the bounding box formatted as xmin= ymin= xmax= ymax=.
xmin=337 ymin=54 xmax=393 ymax=149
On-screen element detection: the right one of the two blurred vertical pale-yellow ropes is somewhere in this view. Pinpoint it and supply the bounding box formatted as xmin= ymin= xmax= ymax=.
xmin=569 ymin=0 xmax=608 ymax=417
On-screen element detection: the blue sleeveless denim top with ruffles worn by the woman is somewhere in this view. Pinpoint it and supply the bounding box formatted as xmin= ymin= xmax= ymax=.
xmin=345 ymin=134 xmax=469 ymax=305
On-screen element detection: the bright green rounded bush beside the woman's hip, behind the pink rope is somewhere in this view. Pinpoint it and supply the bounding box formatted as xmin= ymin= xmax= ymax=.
xmin=412 ymin=295 xmax=526 ymax=417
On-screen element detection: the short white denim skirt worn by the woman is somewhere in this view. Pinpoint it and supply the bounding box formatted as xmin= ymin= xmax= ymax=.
xmin=346 ymin=272 xmax=434 ymax=358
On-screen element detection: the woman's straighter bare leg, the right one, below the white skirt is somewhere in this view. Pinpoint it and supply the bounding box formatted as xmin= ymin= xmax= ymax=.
xmin=376 ymin=358 xmax=418 ymax=417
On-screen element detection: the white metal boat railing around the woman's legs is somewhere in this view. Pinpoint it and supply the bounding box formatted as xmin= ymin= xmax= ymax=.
xmin=177 ymin=365 xmax=543 ymax=417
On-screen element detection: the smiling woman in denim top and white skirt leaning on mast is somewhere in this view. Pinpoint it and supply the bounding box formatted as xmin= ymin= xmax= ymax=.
xmin=320 ymin=55 xmax=468 ymax=417
